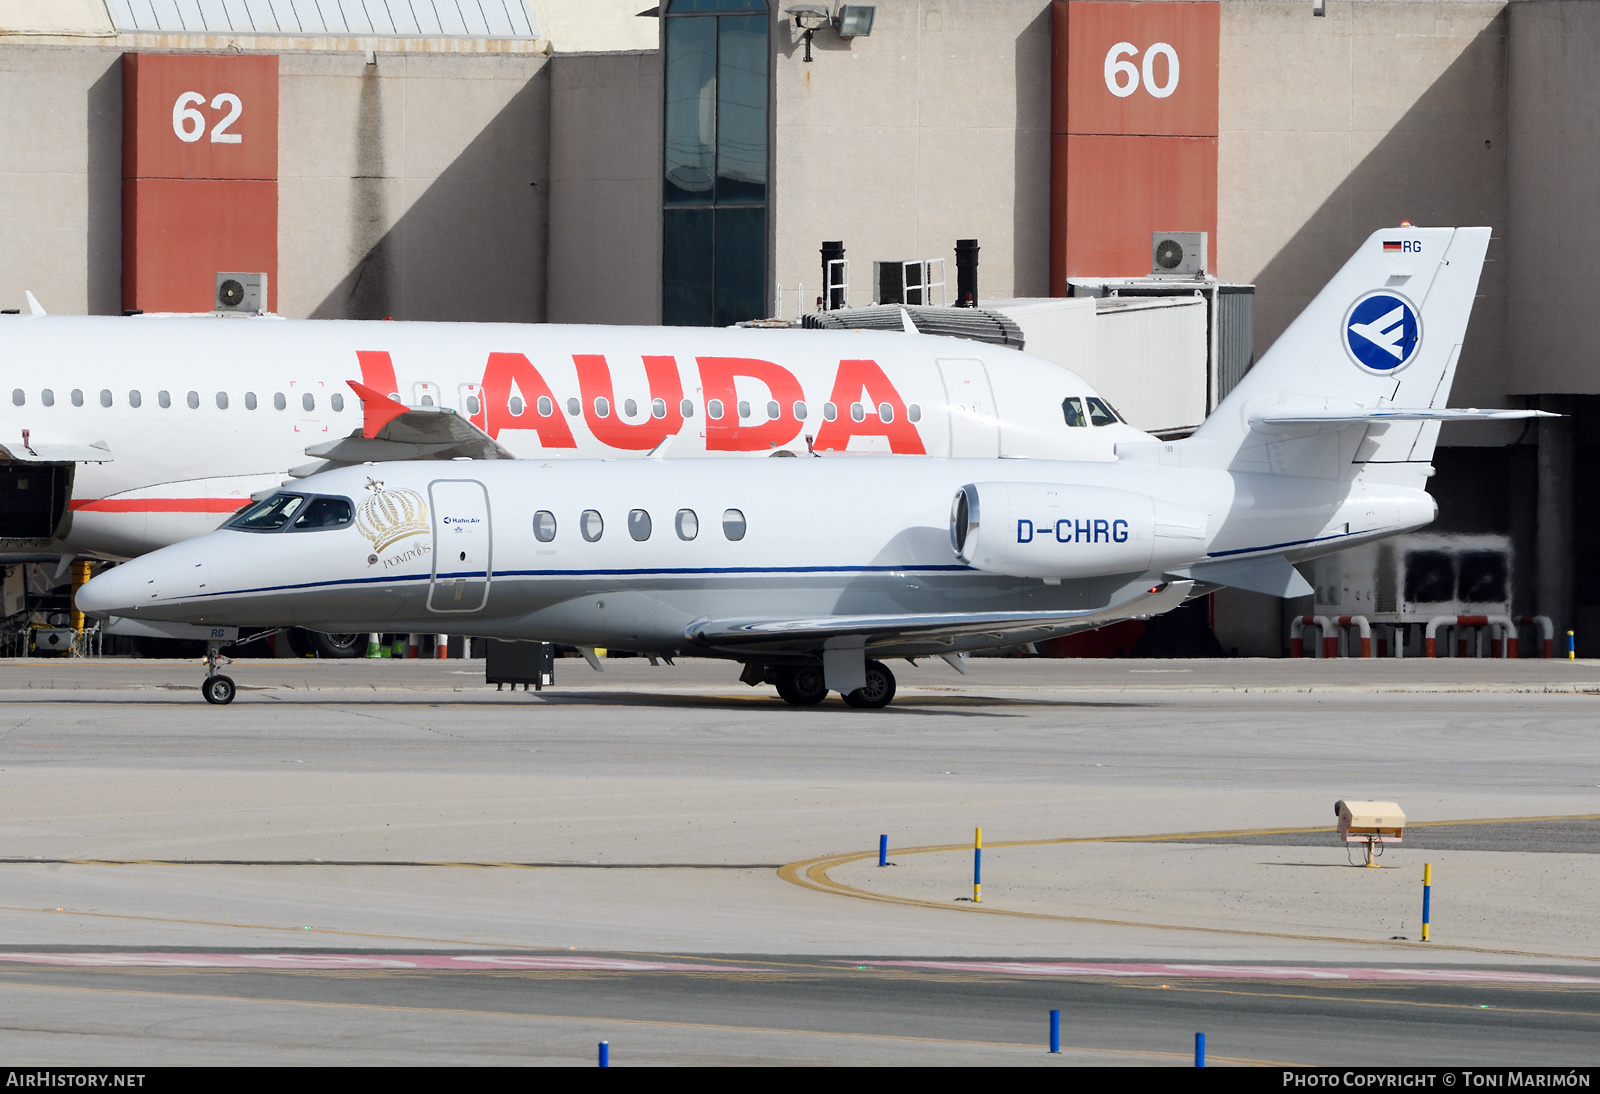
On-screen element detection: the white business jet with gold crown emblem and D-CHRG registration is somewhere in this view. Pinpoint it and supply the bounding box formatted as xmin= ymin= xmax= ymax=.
xmin=78 ymin=227 xmax=1538 ymax=707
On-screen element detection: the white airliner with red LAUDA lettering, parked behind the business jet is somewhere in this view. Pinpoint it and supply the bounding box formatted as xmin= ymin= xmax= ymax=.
xmin=0 ymin=307 xmax=1147 ymax=561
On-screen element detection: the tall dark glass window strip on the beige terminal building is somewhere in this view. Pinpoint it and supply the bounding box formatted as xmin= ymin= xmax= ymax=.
xmin=661 ymin=0 xmax=771 ymax=326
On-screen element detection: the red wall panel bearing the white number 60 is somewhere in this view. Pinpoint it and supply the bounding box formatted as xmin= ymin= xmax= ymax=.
xmin=1050 ymin=0 xmax=1221 ymax=296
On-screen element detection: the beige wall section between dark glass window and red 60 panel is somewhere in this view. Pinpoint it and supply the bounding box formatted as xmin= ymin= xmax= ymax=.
xmin=771 ymin=0 xmax=1051 ymax=311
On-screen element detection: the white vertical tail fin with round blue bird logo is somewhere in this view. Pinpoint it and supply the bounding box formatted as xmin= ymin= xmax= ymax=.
xmin=1186 ymin=227 xmax=1490 ymax=478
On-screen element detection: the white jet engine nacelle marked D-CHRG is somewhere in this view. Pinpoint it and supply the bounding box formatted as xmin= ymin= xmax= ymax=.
xmin=950 ymin=483 xmax=1206 ymax=579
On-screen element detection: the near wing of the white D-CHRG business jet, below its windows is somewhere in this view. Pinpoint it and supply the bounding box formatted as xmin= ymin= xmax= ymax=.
xmin=683 ymin=581 xmax=1194 ymax=651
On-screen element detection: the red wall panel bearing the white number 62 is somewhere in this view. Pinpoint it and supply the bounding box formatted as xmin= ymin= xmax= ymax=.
xmin=122 ymin=53 xmax=278 ymax=312
